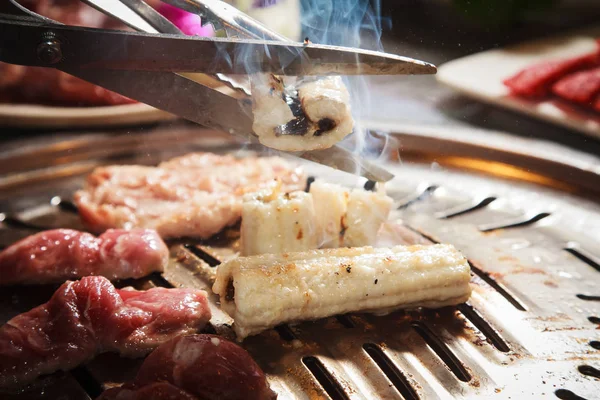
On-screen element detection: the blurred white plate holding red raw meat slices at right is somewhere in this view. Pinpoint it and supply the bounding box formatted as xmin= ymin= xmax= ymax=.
xmin=437 ymin=27 xmax=600 ymax=138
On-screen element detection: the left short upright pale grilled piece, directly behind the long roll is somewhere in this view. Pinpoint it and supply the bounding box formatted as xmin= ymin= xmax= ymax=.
xmin=240 ymin=185 xmax=318 ymax=255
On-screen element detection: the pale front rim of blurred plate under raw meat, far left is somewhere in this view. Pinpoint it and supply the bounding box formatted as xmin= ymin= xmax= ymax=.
xmin=0 ymin=103 xmax=175 ymax=128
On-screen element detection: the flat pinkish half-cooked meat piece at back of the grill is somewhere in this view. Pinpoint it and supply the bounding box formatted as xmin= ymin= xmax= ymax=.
xmin=75 ymin=153 xmax=306 ymax=238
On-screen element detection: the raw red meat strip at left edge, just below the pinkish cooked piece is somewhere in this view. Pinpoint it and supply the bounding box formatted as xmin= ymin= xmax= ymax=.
xmin=0 ymin=229 xmax=169 ymax=286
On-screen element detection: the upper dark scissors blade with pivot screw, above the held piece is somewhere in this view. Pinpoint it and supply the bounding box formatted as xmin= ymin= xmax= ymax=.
xmin=0 ymin=21 xmax=436 ymax=76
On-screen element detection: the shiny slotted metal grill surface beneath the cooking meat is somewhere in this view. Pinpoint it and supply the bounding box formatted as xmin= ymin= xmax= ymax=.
xmin=0 ymin=126 xmax=600 ymax=400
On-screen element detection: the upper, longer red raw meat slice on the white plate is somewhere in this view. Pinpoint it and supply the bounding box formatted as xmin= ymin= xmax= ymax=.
xmin=504 ymin=42 xmax=600 ymax=97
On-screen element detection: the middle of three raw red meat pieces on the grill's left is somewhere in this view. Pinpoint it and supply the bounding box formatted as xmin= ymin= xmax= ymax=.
xmin=0 ymin=276 xmax=211 ymax=388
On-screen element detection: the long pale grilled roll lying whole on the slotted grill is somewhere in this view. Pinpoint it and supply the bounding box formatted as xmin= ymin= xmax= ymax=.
xmin=213 ymin=244 xmax=471 ymax=340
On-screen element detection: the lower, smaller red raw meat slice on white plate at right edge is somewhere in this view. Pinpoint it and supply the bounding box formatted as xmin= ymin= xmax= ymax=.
xmin=552 ymin=67 xmax=600 ymax=105
